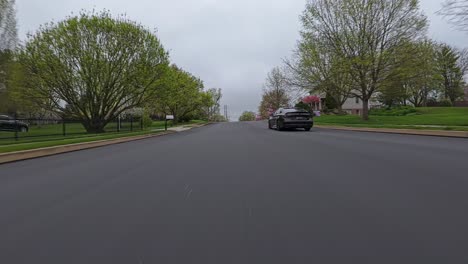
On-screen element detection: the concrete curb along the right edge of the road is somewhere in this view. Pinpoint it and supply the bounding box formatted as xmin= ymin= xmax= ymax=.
xmin=315 ymin=125 xmax=468 ymax=138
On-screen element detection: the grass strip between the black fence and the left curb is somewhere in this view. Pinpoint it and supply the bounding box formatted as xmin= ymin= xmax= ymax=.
xmin=0 ymin=120 xmax=206 ymax=153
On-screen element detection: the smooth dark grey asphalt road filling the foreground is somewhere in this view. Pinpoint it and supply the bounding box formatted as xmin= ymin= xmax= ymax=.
xmin=0 ymin=122 xmax=468 ymax=264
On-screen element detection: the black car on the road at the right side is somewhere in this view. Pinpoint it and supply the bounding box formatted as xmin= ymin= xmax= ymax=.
xmin=268 ymin=108 xmax=314 ymax=131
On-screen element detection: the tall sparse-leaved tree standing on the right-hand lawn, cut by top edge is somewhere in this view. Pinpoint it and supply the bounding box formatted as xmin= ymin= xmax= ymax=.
xmin=297 ymin=0 xmax=426 ymax=119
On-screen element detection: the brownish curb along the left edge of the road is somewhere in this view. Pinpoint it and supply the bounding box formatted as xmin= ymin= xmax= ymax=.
xmin=0 ymin=132 xmax=175 ymax=164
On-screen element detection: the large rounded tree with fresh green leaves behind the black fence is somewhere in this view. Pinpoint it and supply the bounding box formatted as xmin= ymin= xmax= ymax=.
xmin=19 ymin=12 xmax=168 ymax=133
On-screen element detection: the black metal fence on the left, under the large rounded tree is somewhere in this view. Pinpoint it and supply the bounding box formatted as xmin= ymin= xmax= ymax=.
xmin=0 ymin=115 xmax=143 ymax=144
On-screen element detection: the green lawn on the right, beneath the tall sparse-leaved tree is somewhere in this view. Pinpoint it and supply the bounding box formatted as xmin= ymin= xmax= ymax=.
xmin=315 ymin=107 xmax=468 ymax=131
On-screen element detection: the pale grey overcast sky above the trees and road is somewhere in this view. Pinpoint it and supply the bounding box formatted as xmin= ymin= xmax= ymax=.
xmin=17 ymin=0 xmax=468 ymax=120
